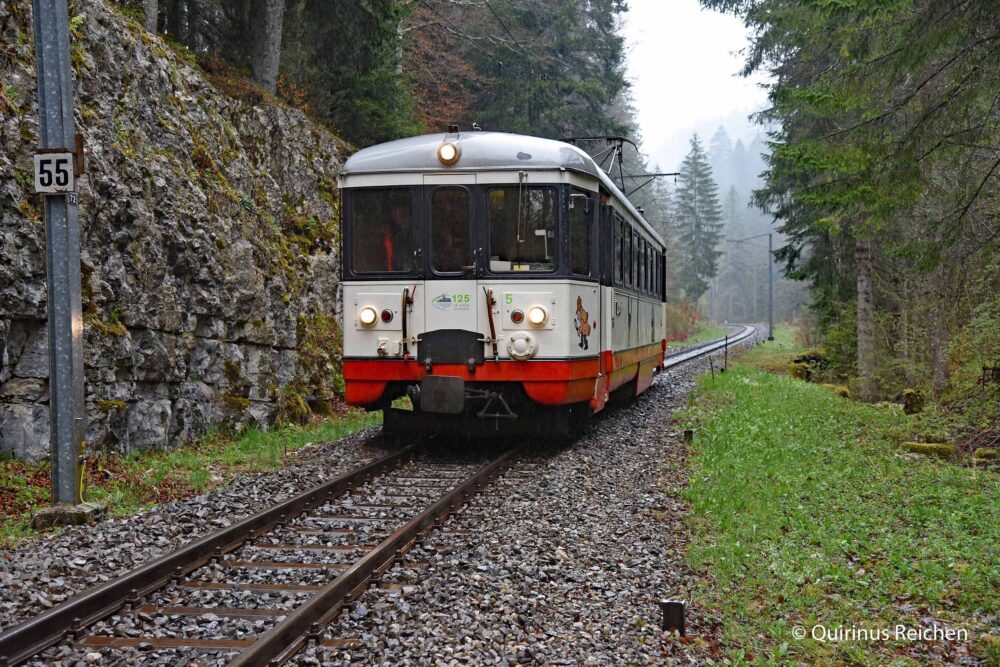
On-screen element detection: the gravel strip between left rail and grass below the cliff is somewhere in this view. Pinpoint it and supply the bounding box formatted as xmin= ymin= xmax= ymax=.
xmin=0 ymin=429 xmax=386 ymax=631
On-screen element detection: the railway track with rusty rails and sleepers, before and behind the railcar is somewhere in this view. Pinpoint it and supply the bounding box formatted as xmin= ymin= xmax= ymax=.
xmin=0 ymin=327 xmax=755 ymax=667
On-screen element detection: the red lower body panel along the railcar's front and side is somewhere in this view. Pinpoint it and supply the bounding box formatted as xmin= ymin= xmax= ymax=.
xmin=344 ymin=343 xmax=665 ymax=412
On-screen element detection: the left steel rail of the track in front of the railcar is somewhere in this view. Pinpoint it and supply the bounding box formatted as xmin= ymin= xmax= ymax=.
xmin=0 ymin=447 xmax=413 ymax=665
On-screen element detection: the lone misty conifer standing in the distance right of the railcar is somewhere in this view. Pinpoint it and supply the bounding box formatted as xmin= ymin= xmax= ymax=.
xmin=675 ymin=134 xmax=722 ymax=302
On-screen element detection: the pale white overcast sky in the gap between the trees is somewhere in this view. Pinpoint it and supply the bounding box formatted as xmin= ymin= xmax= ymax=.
xmin=623 ymin=0 xmax=767 ymax=171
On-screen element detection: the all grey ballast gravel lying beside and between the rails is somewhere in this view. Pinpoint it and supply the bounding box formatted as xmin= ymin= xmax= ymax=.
xmin=0 ymin=342 xmax=752 ymax=666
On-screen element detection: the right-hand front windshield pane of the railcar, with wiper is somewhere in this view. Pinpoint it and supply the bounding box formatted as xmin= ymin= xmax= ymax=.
xmin=487 ymin=186 xmax=559 ymax=271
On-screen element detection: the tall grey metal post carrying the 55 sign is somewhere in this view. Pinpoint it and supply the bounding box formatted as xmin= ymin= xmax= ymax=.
xmin=32 ymin=0 xmax=86 ymax=523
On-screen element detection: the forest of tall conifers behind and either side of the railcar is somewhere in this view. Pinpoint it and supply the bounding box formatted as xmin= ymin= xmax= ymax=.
xmin=119 ymin=0 xmax=1000 ymax=429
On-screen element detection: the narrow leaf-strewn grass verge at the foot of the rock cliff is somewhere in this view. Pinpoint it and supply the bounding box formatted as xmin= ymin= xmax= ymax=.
xmin=0 ymin=410 xmax=382 ymax=549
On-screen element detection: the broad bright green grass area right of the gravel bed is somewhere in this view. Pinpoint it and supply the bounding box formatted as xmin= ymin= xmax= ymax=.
xmin=682 ymin=358 xmax=1000 ymax=665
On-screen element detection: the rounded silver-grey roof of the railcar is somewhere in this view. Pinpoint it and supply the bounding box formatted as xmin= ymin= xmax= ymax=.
xmin=341 ymin=132 xmax=663 ymax=243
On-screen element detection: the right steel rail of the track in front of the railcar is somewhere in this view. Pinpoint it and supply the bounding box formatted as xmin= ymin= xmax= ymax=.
xmin=229 ymin=448 xmax=518 ymax=667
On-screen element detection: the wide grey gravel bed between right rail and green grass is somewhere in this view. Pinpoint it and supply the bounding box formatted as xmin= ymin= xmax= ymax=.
xmin=296 ymin=361 xmax=720 ymax=665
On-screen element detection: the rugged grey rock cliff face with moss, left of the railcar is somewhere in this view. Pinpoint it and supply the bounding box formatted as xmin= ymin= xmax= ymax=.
xmin=0 ymin=0 xmax=344 ymax=458
